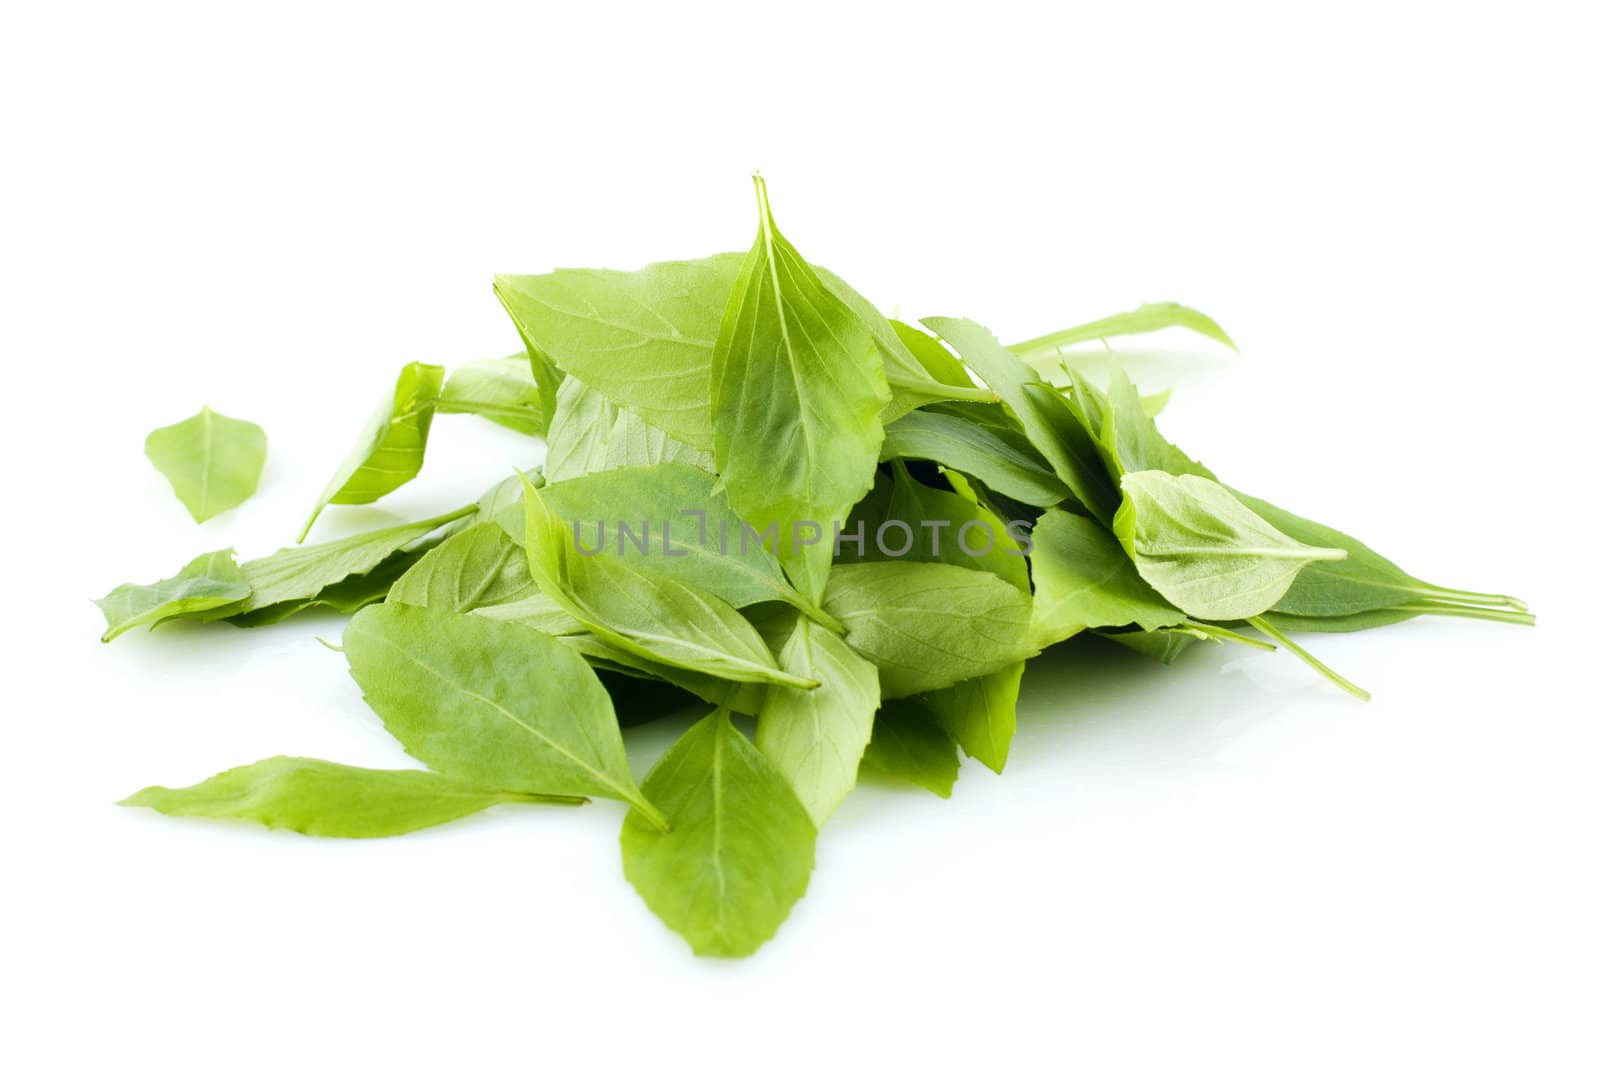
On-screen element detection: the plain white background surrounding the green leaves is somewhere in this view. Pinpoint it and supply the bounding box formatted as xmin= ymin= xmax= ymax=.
xmin=0 ymin=2 xmax=1600 ymax=1064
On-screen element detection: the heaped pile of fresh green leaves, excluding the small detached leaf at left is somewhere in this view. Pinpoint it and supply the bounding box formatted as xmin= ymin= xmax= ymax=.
xmin=101 ymin=179 xmax=1533 ymax=957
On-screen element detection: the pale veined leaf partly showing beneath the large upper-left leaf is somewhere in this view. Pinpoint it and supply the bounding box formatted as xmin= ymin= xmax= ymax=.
xmin=544 ymin=378 xmax=712 ymax=483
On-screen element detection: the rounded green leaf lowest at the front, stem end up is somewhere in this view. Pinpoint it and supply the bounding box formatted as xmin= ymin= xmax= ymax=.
xmin=622 ymin=710 xmax=816 ymax=957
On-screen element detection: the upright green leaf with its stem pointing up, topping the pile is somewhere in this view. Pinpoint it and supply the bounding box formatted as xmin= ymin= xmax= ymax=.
xmin=712 ymin=178 xmax=890 ymax=600
